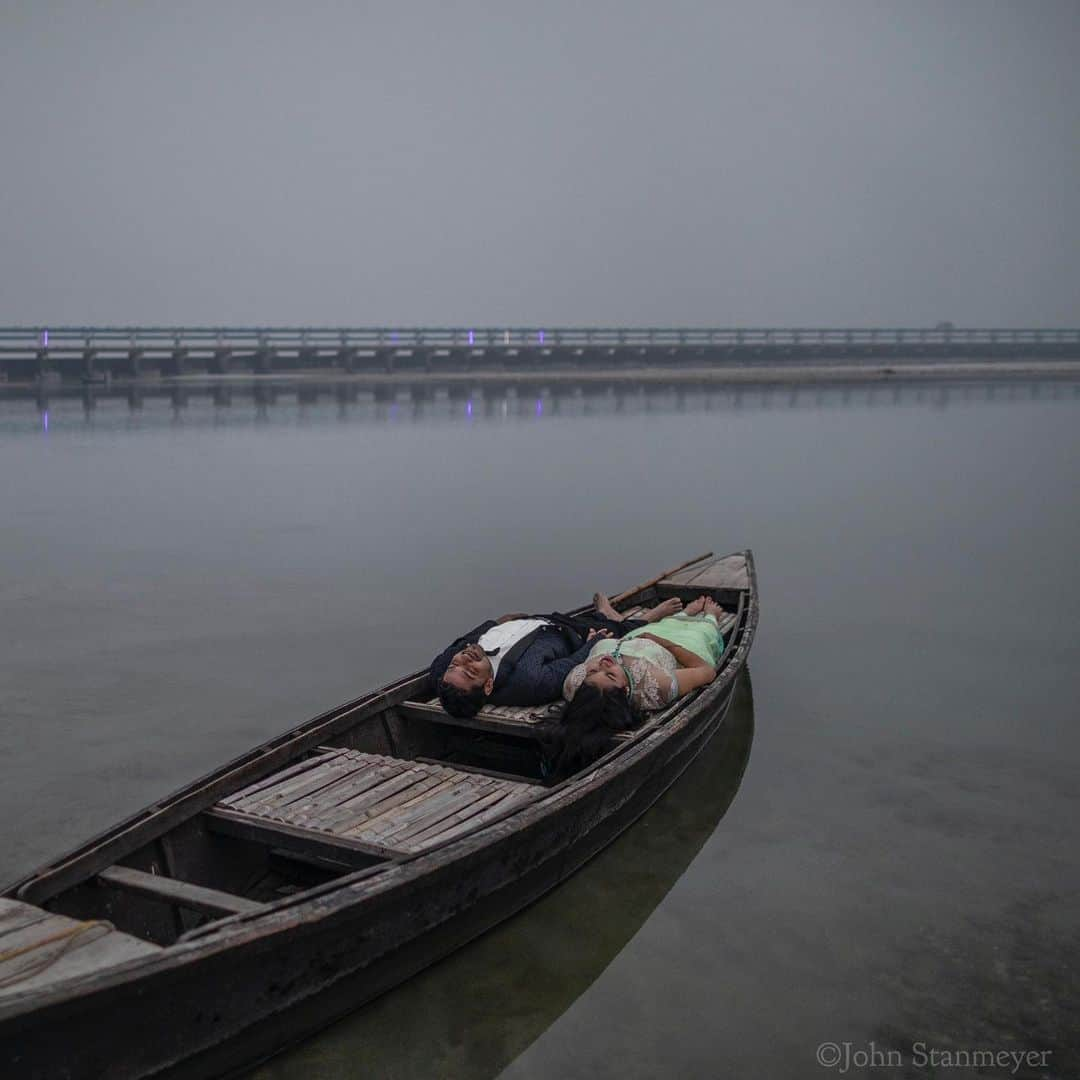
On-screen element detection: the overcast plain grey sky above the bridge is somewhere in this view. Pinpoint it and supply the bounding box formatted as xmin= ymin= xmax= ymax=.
xmin=0 ymin=0 xmax=1080 ymax=326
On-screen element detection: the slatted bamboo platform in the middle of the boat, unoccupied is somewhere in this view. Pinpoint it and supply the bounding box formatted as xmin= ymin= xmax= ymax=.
xmin=204 ymin=748 xmax=538 ymax=861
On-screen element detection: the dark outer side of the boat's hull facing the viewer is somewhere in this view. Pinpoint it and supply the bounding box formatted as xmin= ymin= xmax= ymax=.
xmin=0 ymin=681 xmax=733 ymax=1080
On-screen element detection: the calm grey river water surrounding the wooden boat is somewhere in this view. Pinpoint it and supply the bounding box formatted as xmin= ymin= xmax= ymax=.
xmin=0 ymin=383 xmax=1080 ymax=1080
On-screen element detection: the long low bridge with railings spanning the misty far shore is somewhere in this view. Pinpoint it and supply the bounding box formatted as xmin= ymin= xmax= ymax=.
xmin=0 ymin=323 xmax=1080 ymax=382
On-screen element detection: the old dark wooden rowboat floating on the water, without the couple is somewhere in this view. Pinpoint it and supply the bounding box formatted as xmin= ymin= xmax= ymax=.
xmin=0 ymin=551 xmax=758 ymax=1078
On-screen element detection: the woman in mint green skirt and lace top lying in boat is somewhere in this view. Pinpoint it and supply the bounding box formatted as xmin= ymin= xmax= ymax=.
xmin=543 ymin=596 xmax=726 ymax=779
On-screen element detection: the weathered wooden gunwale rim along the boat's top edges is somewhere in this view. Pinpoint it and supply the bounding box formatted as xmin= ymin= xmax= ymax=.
xmin=0 ymin=549 xmax=758 ymax=1021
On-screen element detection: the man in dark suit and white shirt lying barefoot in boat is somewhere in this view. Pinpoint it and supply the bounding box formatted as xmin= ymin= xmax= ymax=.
xmin=430 ymin=593 xmax=683 ymax=717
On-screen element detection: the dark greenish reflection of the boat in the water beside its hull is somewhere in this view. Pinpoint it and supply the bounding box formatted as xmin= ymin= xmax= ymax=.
xmin=248 ymin=672 xmax=754 ymax=1080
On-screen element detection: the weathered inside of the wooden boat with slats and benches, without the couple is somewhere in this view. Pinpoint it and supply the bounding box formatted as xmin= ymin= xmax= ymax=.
xmin=0 ymin=554 xmax=752 ymax=999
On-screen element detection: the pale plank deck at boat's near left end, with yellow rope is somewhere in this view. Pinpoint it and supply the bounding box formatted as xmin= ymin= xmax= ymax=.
xmin=0 ymin=897 xmax=161 ymax=999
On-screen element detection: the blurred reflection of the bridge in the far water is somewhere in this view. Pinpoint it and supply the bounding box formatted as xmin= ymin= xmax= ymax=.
xmin=8 ymin=378 xmax=1080 ymax=429
